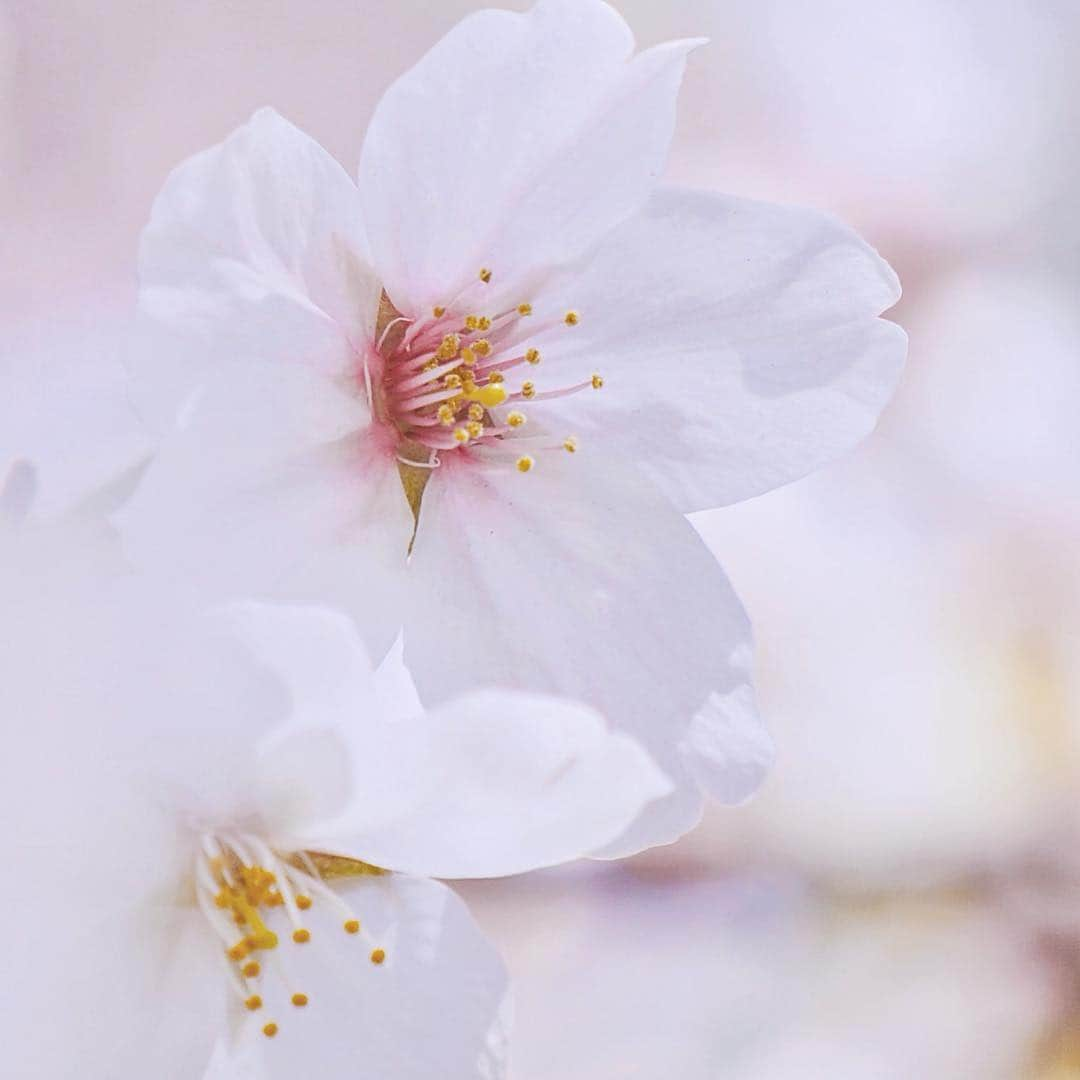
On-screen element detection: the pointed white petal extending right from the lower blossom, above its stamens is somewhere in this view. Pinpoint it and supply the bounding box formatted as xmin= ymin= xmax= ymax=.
xmin=314 ymin=690 xmax=672 ymax=878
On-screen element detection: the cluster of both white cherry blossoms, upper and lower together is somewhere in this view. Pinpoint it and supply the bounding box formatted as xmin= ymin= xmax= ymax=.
xmin=0 ymin=0 xmax=905 ymax=1080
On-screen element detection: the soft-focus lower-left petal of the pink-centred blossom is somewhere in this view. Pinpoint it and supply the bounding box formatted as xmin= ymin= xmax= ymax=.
xmin=117 ymin=364 xmax=413 ymax=654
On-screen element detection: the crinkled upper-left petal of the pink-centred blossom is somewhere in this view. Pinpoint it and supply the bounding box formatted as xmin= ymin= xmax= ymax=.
xmin=135 ymin=109 xmax=379 ymax=427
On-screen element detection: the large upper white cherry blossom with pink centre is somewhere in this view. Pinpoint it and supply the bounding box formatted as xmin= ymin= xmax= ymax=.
xmin=118 ymin=0 xmax=905 ymax=851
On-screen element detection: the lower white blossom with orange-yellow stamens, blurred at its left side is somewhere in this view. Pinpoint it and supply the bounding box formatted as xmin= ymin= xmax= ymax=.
xmin=0 ymin=574 xmax=670 ymax=1080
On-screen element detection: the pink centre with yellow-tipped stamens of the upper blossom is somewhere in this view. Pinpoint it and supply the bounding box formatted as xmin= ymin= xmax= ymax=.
xmin=376 ymin=270 xmax=604 ymax=472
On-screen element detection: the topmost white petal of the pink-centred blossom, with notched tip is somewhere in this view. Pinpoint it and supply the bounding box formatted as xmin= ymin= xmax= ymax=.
xmin=360 ymin=0 xmax=696 ymax=314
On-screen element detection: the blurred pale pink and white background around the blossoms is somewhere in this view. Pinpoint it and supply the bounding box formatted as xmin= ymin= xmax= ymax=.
xmin=0 ymin=0 xmax=1080 ymax=1080
